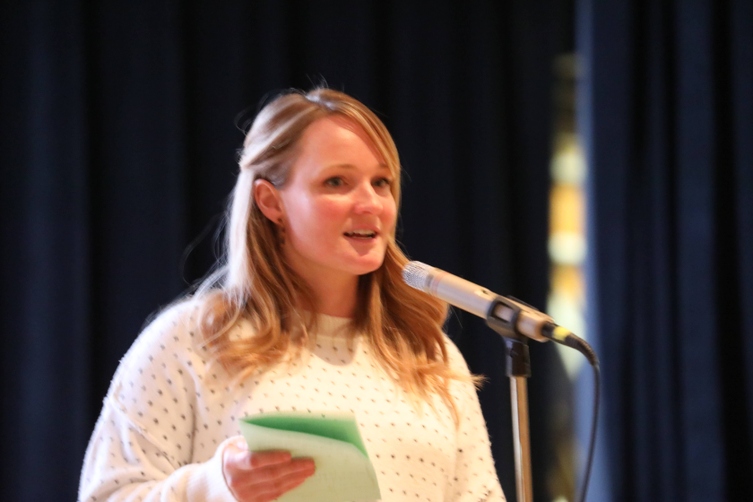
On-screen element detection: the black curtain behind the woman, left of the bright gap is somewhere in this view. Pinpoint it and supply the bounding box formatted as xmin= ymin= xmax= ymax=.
xmin=0 ymin=0 xmax=570 ymax=501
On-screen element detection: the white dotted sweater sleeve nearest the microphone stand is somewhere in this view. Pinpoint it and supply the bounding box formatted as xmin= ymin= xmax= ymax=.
xmin=447 ymin=339 xmax=505 ymax=502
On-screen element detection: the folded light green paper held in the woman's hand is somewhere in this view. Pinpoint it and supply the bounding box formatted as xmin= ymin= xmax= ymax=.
xmin=240 ymin=412 xmax=381 ymax=502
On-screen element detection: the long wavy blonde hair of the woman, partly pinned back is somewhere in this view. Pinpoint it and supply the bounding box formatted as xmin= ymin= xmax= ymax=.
xmin=198 ymin=88 xmax=472 ymax=420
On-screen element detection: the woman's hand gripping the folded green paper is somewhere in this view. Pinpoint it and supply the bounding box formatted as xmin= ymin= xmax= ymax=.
xmin=222 ymin=441 xmax=315 ymax=502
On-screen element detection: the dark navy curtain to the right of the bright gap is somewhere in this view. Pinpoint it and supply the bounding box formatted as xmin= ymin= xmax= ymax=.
xmin=577 ymin=0 xmax=753 ymax=501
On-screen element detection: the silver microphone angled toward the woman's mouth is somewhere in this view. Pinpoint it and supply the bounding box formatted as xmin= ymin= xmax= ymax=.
xmin=403 ymin=261 xmax=579 ymax=347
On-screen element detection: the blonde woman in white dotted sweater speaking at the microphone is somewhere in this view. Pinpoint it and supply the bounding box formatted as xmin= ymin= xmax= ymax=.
xmin=79 ymin=89 xmax=504 ymax=501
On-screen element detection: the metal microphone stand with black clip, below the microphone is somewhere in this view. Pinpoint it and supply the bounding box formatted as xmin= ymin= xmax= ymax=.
xmin=486 ymin=297 xmax=533 ymax=502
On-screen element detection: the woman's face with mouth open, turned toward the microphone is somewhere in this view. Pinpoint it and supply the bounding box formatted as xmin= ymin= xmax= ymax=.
xmin=279 ymin=115 xmax=397 ymax=283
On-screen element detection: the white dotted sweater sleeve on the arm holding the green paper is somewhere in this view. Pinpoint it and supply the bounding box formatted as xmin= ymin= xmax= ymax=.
xmin=79 ymin=307 xmax=234 ymax=502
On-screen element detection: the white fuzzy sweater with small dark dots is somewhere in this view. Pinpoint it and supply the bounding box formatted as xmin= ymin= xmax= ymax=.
xmin=79 ymin=303 xmax=504 ymax=502
